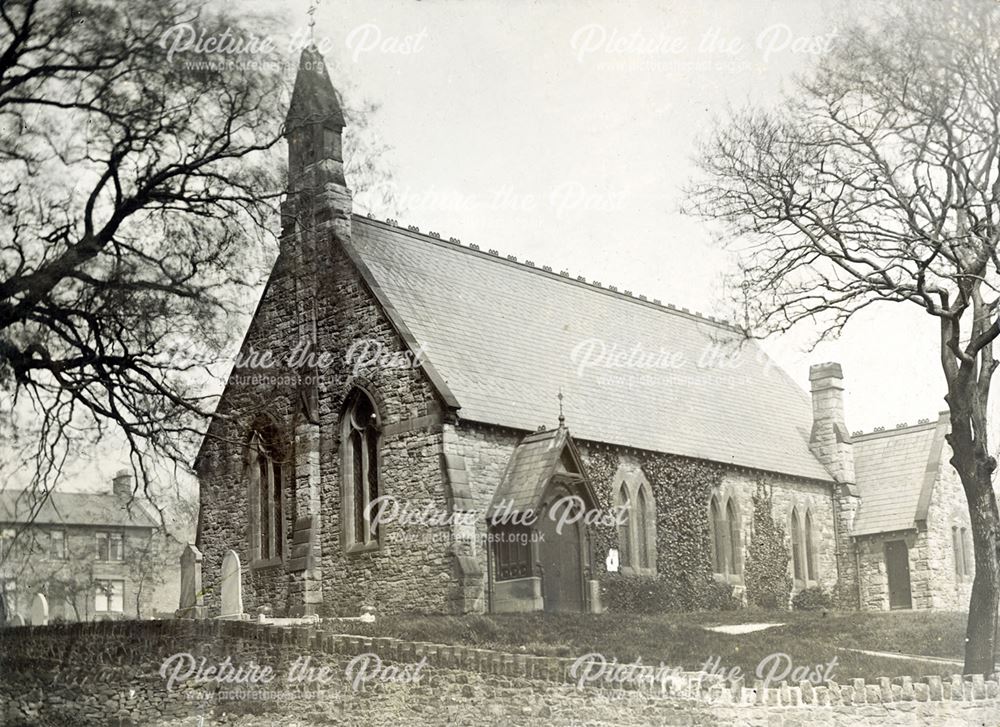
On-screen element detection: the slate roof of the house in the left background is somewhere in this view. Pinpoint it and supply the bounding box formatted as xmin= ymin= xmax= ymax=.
xmin=0 ymin=490 xmax=157 ymax=528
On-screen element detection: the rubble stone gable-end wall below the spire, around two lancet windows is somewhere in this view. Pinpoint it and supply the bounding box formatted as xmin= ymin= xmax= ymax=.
xmin=199 ymin=240 xmax=452 ymax=615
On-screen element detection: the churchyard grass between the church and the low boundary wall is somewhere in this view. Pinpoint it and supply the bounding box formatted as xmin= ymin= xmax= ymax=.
xmin=336 ymin=610 xmax=966 ymax=682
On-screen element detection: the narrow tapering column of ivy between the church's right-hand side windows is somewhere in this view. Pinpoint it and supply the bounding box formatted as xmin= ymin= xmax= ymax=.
xmin=743 ymin=480 xmax=792 ymax=609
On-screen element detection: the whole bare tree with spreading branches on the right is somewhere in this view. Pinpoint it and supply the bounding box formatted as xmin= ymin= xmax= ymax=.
xmin=690 ymin=0 xmax=1000 ymax=673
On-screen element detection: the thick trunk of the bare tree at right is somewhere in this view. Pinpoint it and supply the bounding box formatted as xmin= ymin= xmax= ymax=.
xmin=949 ymin=420 xmax=1000 ymax=674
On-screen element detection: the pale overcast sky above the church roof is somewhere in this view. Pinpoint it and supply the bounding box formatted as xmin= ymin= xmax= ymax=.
xmin=50 ymin=0 xmax=964 ymax=492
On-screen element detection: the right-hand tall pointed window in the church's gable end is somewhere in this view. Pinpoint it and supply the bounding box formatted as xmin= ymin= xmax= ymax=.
xmin=341 ymin=390 xmax=379 ymax=549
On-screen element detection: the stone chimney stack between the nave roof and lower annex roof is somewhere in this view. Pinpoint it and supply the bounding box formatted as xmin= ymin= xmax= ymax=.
xmin=809 ymin=363 xmax=854 ymax=484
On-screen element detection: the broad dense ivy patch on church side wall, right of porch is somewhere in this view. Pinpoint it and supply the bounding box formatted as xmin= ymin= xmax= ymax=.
xmin=584 ymin=450 xmax=726 ymax=611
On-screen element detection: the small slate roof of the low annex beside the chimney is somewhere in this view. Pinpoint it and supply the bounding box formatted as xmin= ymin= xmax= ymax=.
xmin=852 ymin=416 xmax=947 ymax=536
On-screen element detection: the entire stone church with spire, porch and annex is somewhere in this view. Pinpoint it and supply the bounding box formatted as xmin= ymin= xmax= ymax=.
xmin=195 ymin=48 xmax=971 ymax=616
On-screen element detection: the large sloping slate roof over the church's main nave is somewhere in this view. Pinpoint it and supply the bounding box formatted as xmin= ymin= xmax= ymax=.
xmin=349 ymin=216 xmax=831 ymax=481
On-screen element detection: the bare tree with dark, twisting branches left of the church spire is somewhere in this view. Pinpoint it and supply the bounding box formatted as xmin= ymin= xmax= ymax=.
xmin=0 ymin=0 xmax=284 ymax=504
